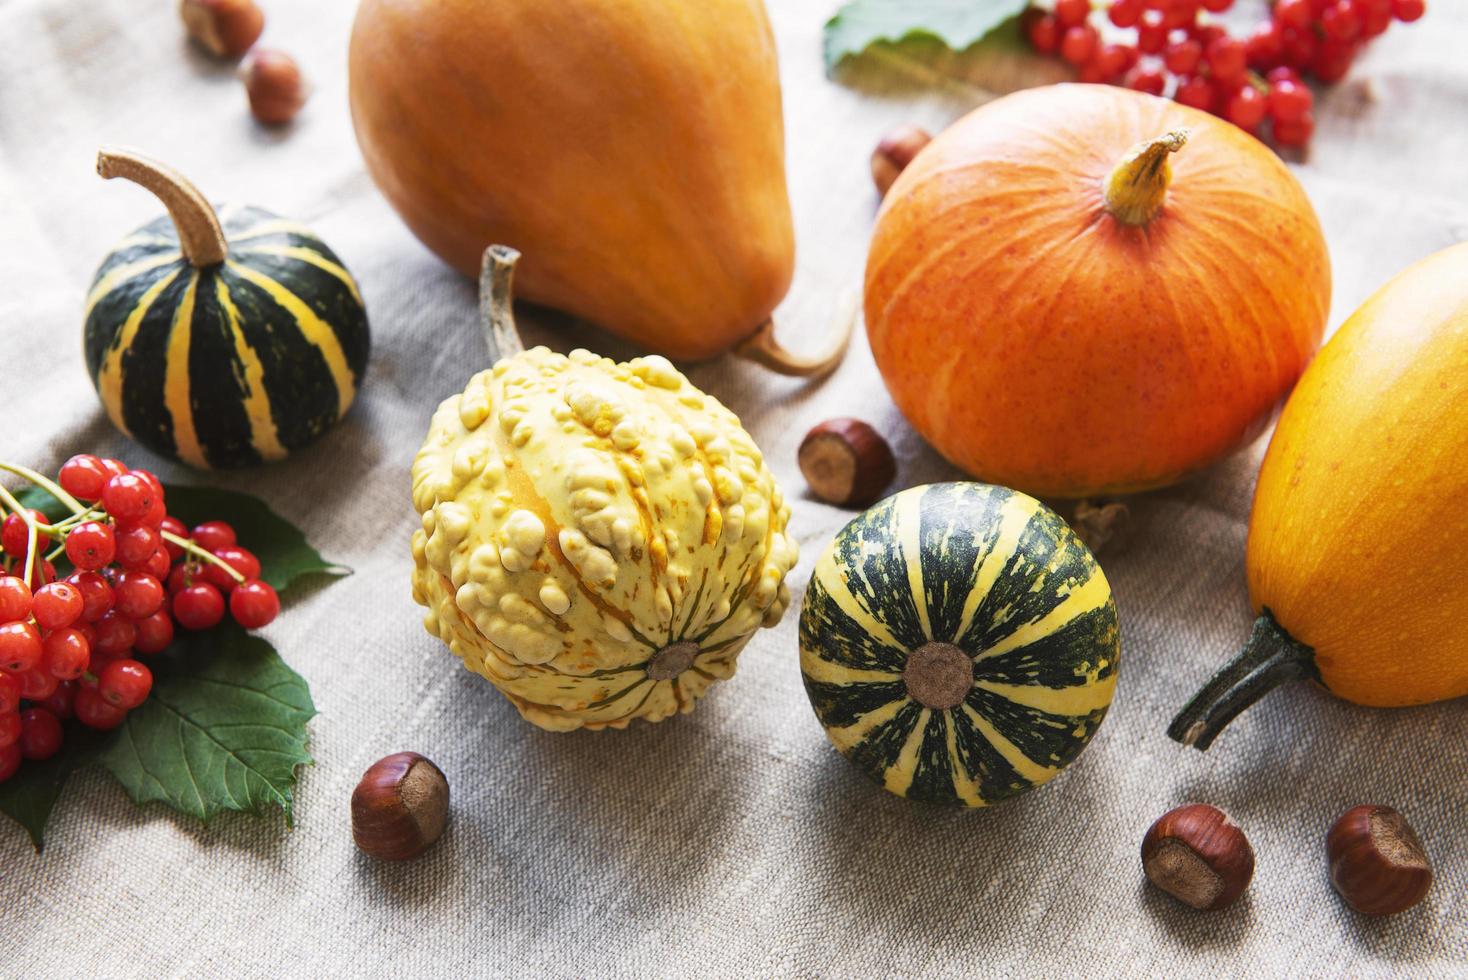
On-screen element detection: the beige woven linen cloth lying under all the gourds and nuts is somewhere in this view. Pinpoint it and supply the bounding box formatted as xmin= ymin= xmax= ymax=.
xmin=0 ymin=0 xmax=1468 ymax=977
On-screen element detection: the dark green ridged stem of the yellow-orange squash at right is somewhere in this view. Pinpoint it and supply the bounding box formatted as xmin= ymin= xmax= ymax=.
xmin=1167 ymin=609 xmax=1320 ymax=750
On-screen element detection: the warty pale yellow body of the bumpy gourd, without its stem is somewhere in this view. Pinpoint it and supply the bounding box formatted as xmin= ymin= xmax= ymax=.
xmin=413 ymin=348 xmax=797 ymax=731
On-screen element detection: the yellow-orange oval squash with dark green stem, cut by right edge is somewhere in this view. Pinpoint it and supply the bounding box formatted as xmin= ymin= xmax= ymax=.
xmin=1169 ymin=245 xmax=1468 ymax=748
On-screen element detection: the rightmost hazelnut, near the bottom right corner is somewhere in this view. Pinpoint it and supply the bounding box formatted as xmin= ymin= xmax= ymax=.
xmin=1326 ymin=804 xmax=1433 ymax=915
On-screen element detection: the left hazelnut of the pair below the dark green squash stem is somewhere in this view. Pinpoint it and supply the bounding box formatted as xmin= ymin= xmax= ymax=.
xmin=1142 ymin=802 xmax=1254 ymax=910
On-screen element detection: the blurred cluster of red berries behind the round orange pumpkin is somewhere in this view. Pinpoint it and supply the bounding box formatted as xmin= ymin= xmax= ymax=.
xmin=1025 ymin=0 xmax=1427 ymax=147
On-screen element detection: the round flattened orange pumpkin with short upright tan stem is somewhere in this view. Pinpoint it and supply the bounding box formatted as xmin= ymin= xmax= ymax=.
xmin=866 ymin=85 xmax=1330 ymax=497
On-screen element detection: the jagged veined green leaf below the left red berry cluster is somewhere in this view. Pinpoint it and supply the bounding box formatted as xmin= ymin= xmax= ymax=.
xmin=95 ymin=624 xmax=316 ymax=826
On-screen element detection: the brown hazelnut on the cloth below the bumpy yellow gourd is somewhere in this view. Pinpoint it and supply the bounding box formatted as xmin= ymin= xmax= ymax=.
xmin=352 ymin=753 xmax=449 ymax=861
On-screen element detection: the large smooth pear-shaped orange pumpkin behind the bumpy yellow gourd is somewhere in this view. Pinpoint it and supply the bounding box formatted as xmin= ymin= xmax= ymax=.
xmin=351 ymin=0 xmax=838 ymax=373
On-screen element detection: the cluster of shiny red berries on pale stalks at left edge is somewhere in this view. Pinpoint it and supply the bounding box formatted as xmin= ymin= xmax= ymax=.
xmin=0 ymin=455 xmax=280 ymax=782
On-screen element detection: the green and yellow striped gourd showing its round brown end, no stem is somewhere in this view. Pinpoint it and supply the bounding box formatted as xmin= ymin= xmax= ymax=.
xmin=800 ymin=483 xmax=1120 ymax=807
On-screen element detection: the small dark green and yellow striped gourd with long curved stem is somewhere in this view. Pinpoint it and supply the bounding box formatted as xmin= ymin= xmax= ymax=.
xmin=85 ymin=150 xmax=370 ymax=468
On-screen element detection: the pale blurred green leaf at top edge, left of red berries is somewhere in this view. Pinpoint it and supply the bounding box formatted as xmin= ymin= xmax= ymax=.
xmin=825 ymin=0 xmax=1029 ymax=72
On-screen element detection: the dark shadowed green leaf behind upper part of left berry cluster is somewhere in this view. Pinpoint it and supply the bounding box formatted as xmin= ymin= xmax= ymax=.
xmin=16 ymin=484 xmax=351 ymax=591
